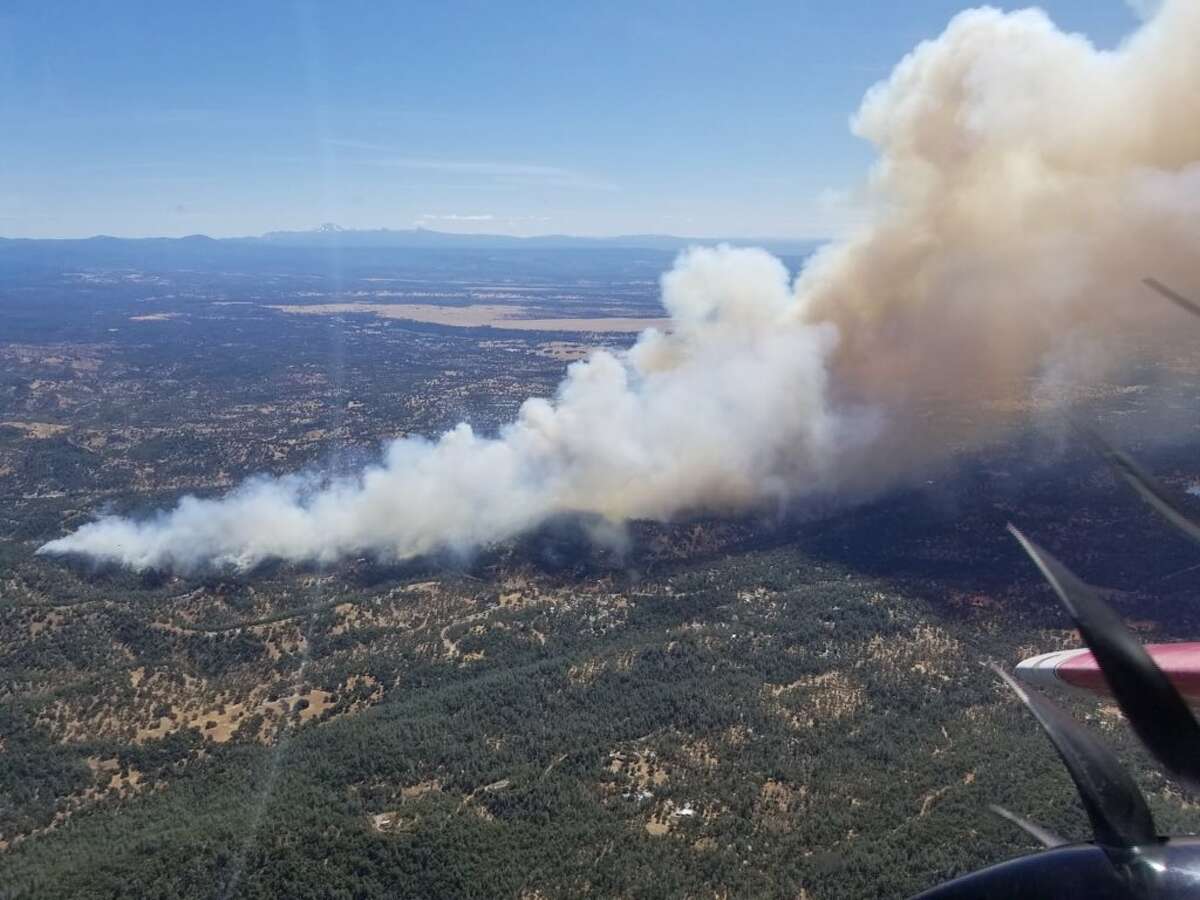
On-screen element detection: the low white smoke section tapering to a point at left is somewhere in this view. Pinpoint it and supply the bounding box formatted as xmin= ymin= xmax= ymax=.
xmin=46 ymin=250 xmax=848 ymax=569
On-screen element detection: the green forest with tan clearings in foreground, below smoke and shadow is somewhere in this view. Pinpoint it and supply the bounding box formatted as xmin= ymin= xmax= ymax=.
xmin=7 ymin=513 xmax=1195 ymax=896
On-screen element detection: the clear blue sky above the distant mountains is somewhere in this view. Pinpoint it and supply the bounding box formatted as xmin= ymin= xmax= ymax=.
xmin=0 ymin=0 xmax=1136 ymax=238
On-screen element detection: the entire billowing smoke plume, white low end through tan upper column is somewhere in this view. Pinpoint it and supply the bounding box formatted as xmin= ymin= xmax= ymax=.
xmin=42 ymin=0 xmax=1200 ymax=569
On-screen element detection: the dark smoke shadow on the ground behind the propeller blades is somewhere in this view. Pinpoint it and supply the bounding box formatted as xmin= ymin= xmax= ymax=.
xmin=792 ymin=433 xmax=1200 ymax=637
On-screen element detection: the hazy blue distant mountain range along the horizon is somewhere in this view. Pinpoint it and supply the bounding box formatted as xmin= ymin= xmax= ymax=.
xmin=0 ymin=224 xmax=823 ymax=269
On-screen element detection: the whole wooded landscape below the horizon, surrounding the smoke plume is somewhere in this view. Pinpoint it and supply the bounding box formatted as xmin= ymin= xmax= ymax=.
xmin=0 ymin=250 xmax=1200 ymax=898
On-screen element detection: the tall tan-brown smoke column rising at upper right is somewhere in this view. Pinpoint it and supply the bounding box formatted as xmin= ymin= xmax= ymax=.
xmin=797 ymin=0 xmax=1200 ymax=487
